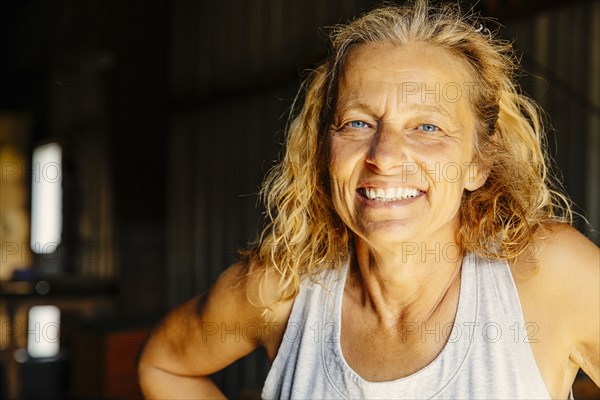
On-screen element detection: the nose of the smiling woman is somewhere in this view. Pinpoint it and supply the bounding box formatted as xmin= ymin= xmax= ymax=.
xmin=366 ymin=125 xmax=408 ymax=173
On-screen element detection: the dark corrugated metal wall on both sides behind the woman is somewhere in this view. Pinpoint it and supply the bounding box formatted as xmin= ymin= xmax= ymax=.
xmin=166 ymin=0 xmax=600 ymax=395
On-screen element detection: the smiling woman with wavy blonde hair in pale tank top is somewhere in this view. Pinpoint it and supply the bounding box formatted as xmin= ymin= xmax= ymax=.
xmin=139 ymin=1 xmax=600 ymax=398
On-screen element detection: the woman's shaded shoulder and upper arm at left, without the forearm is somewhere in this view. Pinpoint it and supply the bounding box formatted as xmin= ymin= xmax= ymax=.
xmin=140 ymin=262 xmax=291 ymax=376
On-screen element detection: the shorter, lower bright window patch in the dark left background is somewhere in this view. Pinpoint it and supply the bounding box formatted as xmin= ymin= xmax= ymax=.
xmin=27 ymin=306 xmax=60 ymax=358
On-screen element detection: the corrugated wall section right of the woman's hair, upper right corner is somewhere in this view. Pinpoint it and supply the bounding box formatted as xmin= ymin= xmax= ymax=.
xmin=506 ymin=1 xmax=600 ymax=244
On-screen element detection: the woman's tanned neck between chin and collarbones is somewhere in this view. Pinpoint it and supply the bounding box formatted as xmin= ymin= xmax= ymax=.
xmin=348 ymin=234 xmax=462 ymax=327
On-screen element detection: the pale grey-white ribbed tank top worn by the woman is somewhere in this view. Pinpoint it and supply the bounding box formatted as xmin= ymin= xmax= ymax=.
xmin=262 ymin=254 xmax=551 ymax=399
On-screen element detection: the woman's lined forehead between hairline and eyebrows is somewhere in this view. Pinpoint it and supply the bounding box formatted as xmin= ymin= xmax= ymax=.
xmin=339 ymin=43 xmax=476 ymax=110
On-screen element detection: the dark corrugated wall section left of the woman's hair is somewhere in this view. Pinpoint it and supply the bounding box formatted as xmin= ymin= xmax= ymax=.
xmin=167 ymin=0 xmax=380 ymax=304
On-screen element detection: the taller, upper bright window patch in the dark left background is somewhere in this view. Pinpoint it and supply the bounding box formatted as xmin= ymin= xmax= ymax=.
xmin=31 ymin=143 xmax=62 ymax=254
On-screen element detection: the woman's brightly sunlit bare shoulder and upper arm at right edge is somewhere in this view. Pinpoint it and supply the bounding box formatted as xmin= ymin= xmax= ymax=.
xmin=511 ymin=224 xmax=600 ymax=384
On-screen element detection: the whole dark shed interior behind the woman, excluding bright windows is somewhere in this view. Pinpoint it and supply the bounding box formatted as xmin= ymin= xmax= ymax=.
xmin=0 ymin=0 xmax=600 ymax=398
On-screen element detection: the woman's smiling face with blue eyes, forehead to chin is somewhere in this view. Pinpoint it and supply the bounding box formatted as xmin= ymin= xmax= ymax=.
xmin=329 ymin=43 xmax=486 ymax=246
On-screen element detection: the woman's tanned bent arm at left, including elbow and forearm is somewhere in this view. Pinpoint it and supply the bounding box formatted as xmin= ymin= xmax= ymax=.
xmin=138 ymin=264 xmax=288 ymax=399
